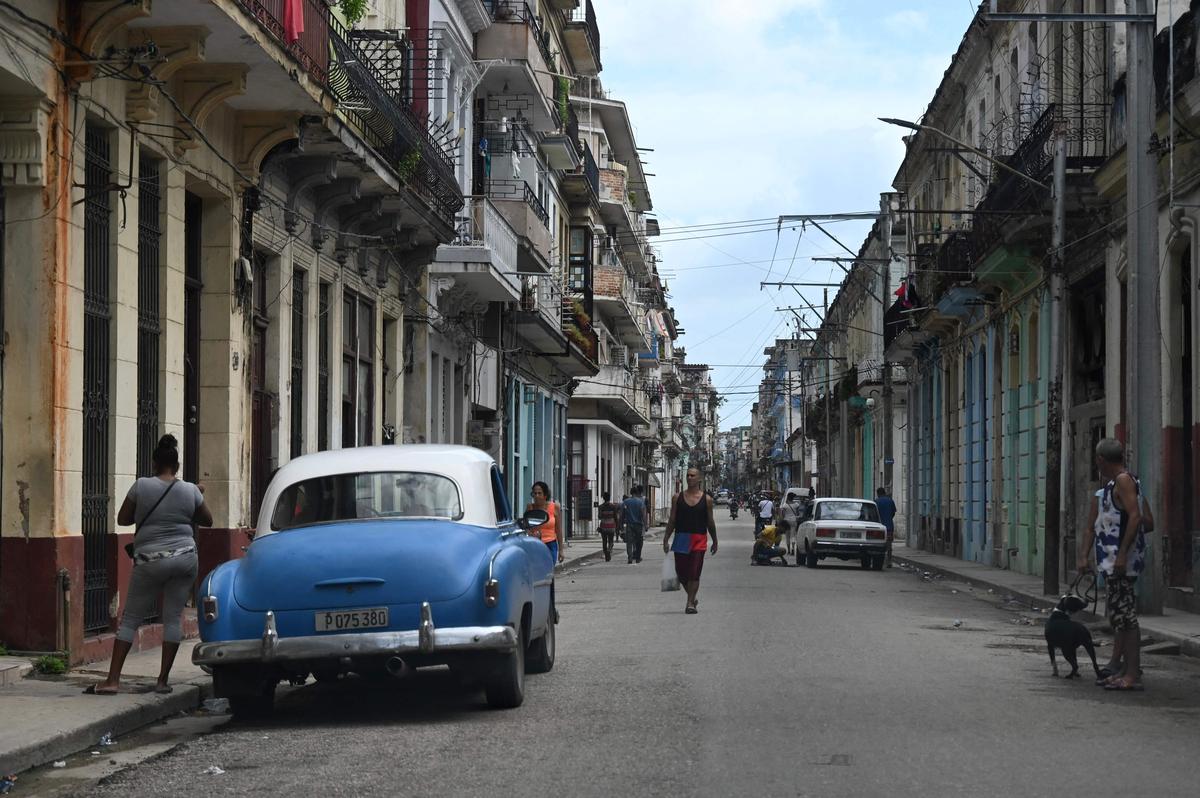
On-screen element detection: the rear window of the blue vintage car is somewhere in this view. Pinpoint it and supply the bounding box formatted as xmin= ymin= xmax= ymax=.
xmin=271 ymin=472 xmax=462 ymax=529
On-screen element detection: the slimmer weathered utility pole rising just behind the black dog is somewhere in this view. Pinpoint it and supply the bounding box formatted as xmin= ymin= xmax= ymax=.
xmin=1042 ymin=116 xmax=1067 ymax=595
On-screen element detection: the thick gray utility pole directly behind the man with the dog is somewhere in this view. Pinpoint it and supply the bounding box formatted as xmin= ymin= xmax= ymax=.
xmin=1126 ymin=0 xmax=1174 ymax=614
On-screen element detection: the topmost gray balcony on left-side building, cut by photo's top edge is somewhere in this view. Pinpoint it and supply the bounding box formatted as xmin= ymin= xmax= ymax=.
xmin=475 ymin=0 xmax=562 ymax=133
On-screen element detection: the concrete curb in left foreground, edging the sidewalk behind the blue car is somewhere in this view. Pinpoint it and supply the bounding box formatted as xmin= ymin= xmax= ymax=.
xmin=0 ymin=683 xmax=212 ymax=774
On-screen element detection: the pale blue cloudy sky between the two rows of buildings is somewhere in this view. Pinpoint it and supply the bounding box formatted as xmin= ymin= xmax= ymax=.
xmin=594 ymin=0 xmax=977 ymax=430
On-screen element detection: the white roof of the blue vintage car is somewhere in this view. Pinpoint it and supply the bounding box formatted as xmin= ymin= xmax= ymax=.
xmin=256 ymin=444 xmax=497 ymax=536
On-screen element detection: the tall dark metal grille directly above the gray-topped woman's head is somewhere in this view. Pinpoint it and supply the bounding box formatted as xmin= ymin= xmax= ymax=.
xmin=138 ymin=156 xmax=162 ymax=476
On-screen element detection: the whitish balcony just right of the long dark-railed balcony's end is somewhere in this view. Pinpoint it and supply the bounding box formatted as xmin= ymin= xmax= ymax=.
xmin=430 ymin=199 xmax=522 ymax=302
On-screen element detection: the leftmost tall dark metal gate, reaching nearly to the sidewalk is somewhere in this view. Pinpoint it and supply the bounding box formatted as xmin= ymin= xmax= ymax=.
xmin=82 ymin=125 xmax=113 ymax=631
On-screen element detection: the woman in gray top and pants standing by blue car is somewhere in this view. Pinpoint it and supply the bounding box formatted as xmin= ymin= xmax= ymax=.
xmin=89 ymin=434 xmax=212 ymax=695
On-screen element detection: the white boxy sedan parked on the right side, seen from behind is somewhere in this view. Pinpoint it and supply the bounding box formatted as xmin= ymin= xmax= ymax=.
xmin=799 ymin=498 xmax=888 ymax=571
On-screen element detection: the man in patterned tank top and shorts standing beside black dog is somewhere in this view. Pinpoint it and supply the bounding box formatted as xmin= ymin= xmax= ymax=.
xmin=1079 ymin=438 xmax=1154 ymax=690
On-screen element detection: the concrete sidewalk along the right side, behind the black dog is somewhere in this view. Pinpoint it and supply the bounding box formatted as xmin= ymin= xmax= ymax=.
xmin=892 ymin=547 xmax=1200 ymax=656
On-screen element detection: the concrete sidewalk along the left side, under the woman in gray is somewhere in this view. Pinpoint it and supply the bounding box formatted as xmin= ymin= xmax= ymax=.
xmin=0 ymin=530 xmax=633 ymax=775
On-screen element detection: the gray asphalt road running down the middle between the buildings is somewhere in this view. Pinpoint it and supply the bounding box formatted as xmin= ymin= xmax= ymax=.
xmin=68 ymin=521 xmax=1200 ymax=798
